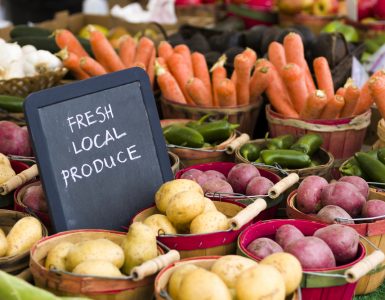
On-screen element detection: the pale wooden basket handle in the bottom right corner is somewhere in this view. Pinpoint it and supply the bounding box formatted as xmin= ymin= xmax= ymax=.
xmin=345 ymin=250 xmax=385 ymax=283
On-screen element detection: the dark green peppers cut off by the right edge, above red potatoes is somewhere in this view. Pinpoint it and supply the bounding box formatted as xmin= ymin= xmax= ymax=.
xmin=340 ymin=148 xmax=385 ymax=183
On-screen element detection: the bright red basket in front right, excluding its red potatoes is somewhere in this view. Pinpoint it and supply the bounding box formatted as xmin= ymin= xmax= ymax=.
xmin=238 ymin=219 xmax=366 ymax=300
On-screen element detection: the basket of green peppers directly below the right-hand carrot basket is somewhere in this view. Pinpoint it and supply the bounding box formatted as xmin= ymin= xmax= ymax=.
xmin=235 ymin=134 xmax=334 ymax=179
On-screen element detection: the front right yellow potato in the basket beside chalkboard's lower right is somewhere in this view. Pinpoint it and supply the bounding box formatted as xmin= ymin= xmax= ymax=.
xmin=190 ymin=211 xmax=229 ymax=234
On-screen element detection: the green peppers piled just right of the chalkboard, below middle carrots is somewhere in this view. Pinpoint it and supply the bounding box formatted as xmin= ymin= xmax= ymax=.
xmin=163 ymin=115 xmax=239 ymax=148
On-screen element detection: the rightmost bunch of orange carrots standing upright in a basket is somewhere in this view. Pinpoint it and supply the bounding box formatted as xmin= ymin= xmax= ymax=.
xmin=254 ymin=33 xmax=372 ymax=119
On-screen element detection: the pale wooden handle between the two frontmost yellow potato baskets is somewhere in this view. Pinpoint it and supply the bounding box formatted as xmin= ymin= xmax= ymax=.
xmin=131 ymin=250 xmax=180 ymax=281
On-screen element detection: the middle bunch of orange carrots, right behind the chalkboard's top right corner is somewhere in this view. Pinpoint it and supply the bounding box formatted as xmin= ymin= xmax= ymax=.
xmin=155 ymin=41 xmax=261 ymax=107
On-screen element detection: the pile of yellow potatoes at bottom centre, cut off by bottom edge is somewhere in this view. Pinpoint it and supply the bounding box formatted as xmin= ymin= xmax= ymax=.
xmin=168 ymin=253 xmax=302 ymax=300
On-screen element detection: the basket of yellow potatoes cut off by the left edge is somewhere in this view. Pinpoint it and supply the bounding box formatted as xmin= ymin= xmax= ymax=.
xmin=0 ymin=209 xmax=48 ymax=275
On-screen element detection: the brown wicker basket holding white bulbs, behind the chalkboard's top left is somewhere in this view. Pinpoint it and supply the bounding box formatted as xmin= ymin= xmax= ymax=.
xmin=0 ymin=68 xmax=68 ymax=97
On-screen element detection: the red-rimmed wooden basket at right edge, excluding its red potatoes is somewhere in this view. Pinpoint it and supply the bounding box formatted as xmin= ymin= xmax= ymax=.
xmin=286 ymin=188 xmax=385 ymax=295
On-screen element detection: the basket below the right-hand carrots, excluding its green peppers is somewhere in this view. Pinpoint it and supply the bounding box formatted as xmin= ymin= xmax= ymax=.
xmin=235 ymin=139 xmax=334 ymax=180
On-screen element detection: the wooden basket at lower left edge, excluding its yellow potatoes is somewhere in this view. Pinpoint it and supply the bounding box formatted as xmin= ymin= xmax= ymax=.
xmin=0 ymin=209 xmax=48 ymax=275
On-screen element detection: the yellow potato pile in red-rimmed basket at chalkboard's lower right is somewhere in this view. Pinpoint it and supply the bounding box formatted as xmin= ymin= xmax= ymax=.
xmin=143 ymin=179 xmax=229 ymax=234
